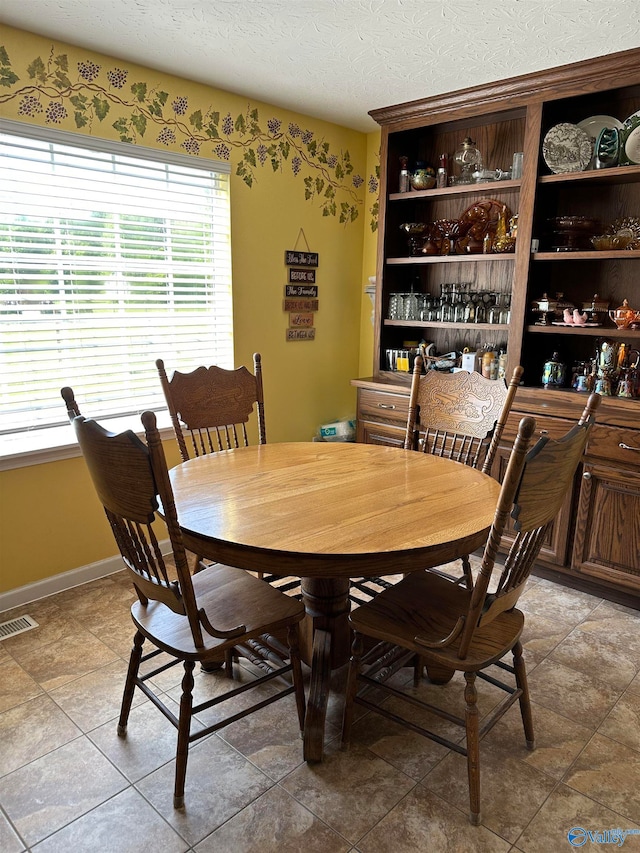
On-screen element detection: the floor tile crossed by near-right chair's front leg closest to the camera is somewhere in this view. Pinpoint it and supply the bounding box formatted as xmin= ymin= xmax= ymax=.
xmin=422 ymin=741 xmax=555 ymax=844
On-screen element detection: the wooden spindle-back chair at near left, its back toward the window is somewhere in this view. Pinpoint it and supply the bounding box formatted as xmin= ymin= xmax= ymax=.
xmin=65 ymin=389 xmax=305 ymax=808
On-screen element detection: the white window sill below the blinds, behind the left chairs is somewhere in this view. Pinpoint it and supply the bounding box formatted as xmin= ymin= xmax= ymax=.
xmin=0 ymin=410 xmax=174 ymax=471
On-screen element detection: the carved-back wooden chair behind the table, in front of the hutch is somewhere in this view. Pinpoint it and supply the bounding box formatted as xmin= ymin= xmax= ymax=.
xmin=404 ymin=356 xmax=523 ymax=588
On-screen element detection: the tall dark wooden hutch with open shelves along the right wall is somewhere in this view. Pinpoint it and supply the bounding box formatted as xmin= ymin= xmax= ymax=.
xmin=353 ymin=49 xmax=640 ymax=606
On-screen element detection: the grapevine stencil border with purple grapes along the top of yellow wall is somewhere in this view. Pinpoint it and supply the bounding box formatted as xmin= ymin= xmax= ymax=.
xmin=0 ymin=45 xmax=379 ymax=231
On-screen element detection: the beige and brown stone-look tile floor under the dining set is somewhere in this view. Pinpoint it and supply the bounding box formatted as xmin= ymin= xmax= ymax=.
xmin=0 ymin=573 xmax=640 ymax=853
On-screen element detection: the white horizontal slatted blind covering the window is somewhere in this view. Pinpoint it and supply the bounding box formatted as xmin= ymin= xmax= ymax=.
xmin=0 ymin=122 xmax=233 ymax=434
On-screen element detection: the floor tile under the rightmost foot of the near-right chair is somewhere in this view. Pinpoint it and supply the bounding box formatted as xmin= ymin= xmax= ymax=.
xmin=482 ymin=702 xmax=593 ymax=779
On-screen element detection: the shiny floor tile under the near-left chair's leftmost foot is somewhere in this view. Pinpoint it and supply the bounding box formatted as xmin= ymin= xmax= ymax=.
xmin=88 ymin=702 xmax=184 ymax=782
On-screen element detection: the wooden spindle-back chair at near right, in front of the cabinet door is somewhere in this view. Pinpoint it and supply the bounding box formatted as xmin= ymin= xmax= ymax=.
xmin=342 ymin=394 xmax=600 ymax=824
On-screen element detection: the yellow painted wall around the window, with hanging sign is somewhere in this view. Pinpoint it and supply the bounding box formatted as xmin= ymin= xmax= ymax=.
xmin=0 ymin=27 xmax=378 ymax=592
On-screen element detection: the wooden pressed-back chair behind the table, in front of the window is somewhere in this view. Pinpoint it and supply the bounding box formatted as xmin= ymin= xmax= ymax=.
xmin=156 ymin=353 xmax=267 ymax=462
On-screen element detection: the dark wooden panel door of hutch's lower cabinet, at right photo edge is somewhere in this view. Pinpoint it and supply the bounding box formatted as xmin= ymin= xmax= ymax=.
xmin=571 ymin=464 xmax=640 ymax=590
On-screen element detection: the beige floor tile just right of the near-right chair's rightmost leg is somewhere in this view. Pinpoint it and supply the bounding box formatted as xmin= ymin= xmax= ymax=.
xmin=529 ymin=659 xmax=622 ymax=730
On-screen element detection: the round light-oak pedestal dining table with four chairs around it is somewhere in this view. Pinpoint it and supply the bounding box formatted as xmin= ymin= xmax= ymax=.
xmin=169 ymin=442 xmax=500 ymax=761
